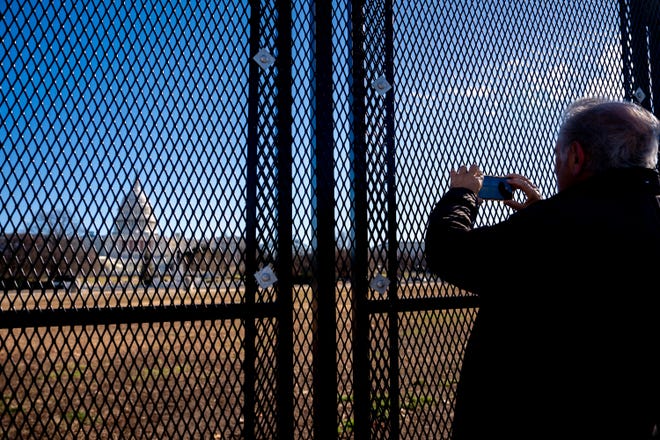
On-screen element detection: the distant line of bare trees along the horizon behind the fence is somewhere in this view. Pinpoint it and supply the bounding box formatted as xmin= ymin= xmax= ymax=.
xmin=0 ymin=232 xmax=423 ymax=290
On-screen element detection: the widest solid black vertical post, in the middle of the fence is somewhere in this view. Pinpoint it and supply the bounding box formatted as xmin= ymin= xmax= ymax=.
xmin=312 ymin=0 xmax=338 ymax=439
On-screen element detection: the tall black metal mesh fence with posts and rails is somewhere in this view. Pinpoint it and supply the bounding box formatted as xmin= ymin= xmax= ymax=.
xmin=0 ymin=0 xmax=660 ymax=439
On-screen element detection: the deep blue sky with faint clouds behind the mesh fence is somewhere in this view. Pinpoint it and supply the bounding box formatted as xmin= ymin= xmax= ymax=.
xmin=0 ymin=0 xmax=623 ymax=241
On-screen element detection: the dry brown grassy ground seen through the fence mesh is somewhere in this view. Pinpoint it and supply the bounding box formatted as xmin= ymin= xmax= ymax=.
xmin=0 ymin=283 xmax=472 ymax=439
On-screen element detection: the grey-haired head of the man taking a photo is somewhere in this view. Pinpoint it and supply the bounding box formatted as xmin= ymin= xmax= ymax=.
xmin=555 ymin=98 xmax=660 ymax=191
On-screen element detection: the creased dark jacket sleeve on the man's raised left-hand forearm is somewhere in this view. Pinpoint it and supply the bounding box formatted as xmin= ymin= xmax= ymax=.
xmin=424 ymin=188 xmax=478 ymax=285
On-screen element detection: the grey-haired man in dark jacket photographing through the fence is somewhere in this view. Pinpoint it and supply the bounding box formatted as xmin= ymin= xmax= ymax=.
xmin=425 ymin=99 xmax=660 ymax=440
